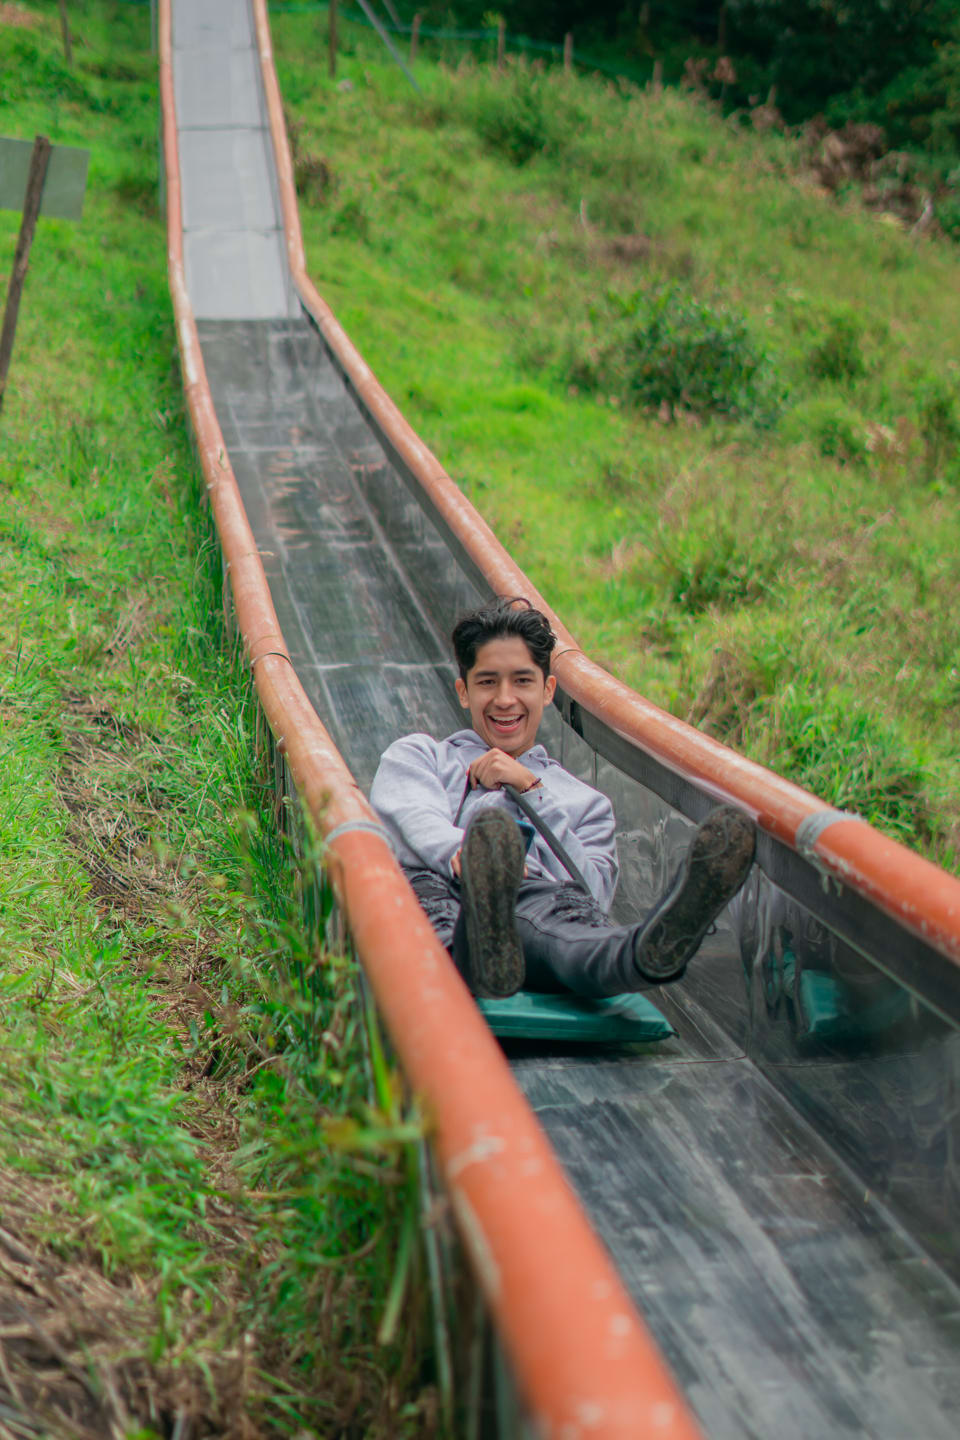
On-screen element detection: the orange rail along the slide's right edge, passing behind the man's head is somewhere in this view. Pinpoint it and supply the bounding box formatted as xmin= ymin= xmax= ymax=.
xmin=253 ymin=0 xmax=960 ymax=965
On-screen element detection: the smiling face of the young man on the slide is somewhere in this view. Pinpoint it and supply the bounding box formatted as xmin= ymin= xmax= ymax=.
xmin=456 ymin=635 xmax=557 ymax=756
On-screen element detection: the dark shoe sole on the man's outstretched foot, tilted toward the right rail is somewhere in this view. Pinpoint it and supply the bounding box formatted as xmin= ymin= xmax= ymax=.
xmin=633 ymin=805 xmax=757 ymax=982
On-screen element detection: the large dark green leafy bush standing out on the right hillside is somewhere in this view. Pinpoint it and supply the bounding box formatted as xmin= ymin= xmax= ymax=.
xmin=567 ymin=284 xmax=783 ymax=425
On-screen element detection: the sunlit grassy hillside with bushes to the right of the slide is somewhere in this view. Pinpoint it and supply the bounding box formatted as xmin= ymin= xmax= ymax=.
xmin=273 ymin=13 xmax=960 ymax=868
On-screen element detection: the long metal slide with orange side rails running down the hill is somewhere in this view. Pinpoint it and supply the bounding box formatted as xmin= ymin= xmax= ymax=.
xmin=161 ymin=0 xmax=960 ymax=1440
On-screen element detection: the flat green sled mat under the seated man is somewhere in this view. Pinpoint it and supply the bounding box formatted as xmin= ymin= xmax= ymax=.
xmin=476 ymin=991 xmax=676 ymax=1044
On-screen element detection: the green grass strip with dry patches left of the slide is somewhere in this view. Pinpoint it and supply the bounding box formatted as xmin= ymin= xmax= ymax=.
xmin=0 ymin=0 xmax=430 ymax=1436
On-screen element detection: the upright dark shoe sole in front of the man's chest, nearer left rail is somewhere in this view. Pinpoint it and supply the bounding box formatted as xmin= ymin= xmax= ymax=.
xmin=461 ymin=811 xmax=525 ymax=999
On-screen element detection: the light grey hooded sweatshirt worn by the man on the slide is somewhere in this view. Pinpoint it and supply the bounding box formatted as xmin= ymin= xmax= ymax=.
xmin=370 ymin=730 xmax=617 ymax=910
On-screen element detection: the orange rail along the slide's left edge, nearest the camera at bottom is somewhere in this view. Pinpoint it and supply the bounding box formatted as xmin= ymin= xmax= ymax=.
xmin=158 ymin=0 xmax=699 ymax=1440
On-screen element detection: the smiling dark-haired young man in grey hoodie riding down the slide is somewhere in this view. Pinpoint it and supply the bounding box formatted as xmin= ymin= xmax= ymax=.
xmin=370 ymin=599 xmax=754 ymax=996
